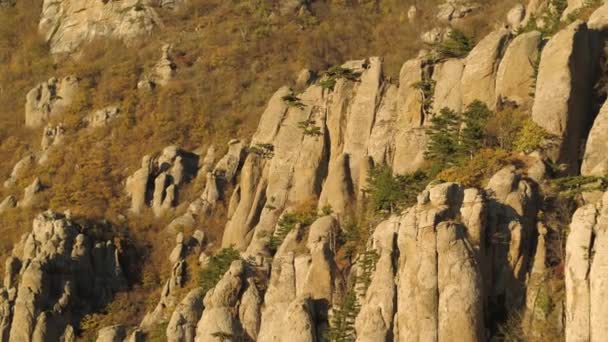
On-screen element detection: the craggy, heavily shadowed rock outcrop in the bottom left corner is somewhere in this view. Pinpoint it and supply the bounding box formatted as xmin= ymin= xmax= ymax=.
xmin=0 ymin=212 xmax=126 ymax=341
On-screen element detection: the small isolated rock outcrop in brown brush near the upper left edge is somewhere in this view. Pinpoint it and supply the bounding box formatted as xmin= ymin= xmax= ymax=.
xmin=25 ymin=76 xmax=78 ymax=127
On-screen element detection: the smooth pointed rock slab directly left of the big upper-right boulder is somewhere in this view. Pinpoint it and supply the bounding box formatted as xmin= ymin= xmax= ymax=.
xmin=496 ymin=31 xmax=541 ymax=108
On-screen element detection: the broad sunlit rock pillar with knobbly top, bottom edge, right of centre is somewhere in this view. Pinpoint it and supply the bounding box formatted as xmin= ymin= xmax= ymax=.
xmin=395 ymin=183 xmax=485 ymax=341
